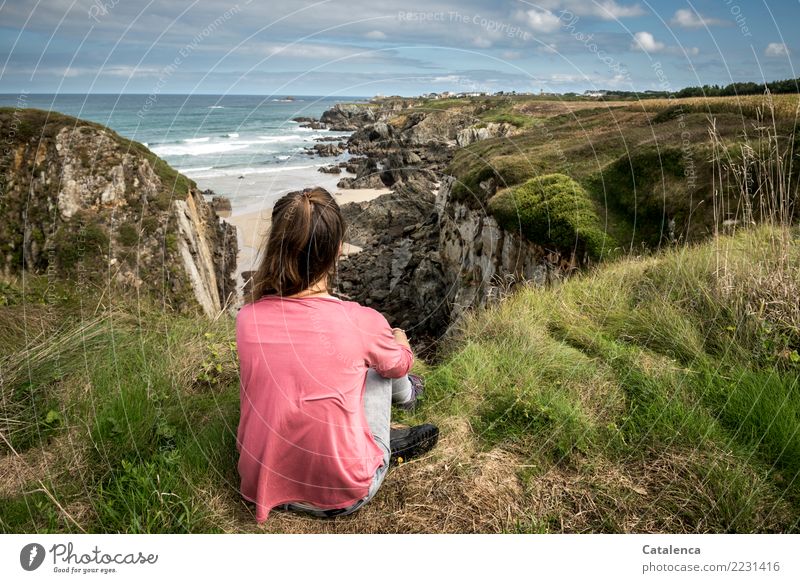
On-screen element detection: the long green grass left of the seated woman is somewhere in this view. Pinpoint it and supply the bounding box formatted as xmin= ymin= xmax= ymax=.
xmin=0 ymin=288 xmax=238 ymax=533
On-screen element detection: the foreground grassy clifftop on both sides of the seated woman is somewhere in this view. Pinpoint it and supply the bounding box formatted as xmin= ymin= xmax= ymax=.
xmin=0 ymin=227 xmax=800 ymax=532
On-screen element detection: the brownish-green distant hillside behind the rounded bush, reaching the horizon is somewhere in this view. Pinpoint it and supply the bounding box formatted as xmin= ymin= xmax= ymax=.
xmin=440 ymin=95 xmax=800 ymax=255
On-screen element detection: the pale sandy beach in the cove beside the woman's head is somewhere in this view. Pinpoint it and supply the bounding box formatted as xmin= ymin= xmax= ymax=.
xmin=223 ymin=188 xmax=391 ymax=274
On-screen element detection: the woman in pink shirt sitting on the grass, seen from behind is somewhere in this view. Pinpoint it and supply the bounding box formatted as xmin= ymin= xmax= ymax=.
xmin=236 ymin=188 xmax=439 ymax=522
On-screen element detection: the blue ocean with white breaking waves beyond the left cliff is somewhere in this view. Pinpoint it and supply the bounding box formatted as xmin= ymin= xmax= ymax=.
xmin=0 ymin=94 xmax=363 ymax=206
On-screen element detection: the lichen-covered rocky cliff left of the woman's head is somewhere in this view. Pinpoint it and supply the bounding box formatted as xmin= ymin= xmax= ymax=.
xmin=0 ymin=109 xmax=237 ymax=316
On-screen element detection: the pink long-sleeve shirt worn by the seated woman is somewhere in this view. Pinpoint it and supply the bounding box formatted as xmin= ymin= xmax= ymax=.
xmin=236 ymin=296 xmax=413 ymax=522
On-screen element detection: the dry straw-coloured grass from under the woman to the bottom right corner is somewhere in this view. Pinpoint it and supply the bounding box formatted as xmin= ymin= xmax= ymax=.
xmin=195 ymin=408 xmax=791 ymax=534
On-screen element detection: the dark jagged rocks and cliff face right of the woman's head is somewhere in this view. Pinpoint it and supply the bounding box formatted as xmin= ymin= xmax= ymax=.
xmin=321 ymin=102 xmax=559 ymax=346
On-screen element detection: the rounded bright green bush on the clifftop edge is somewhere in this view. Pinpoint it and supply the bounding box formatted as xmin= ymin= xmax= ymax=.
xmin=489 ymin=174 xmax=610 ymax=259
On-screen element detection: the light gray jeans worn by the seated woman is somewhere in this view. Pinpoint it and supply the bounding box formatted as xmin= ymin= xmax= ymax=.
xmin=279 ymin=369 xmax=413 ymax=518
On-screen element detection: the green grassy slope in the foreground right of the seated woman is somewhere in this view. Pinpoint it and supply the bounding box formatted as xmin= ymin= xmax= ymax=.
xmin=429 ymin=229 xmax=800 ymax=532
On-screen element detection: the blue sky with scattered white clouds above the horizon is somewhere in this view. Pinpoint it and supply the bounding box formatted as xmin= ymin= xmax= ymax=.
xmin=0 ymin=0 xmax=800 ymax=96
